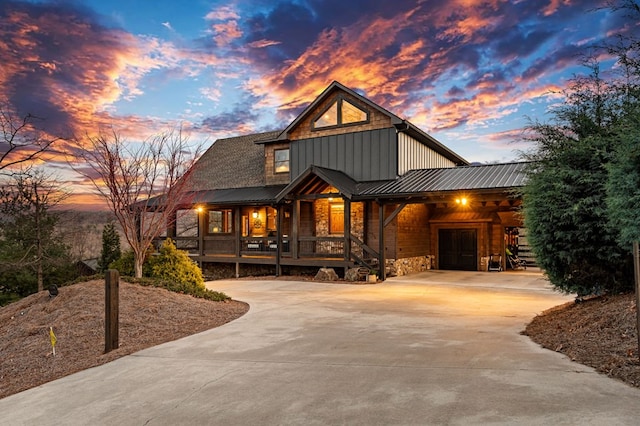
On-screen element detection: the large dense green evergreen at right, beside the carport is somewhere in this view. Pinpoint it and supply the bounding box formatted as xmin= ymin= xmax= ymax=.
xmin=523 ymin=1 xmax=640 ymax=295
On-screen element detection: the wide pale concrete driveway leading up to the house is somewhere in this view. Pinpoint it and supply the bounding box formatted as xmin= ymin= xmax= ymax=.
xmin=0 ymin=271 xmax=640 ymax=426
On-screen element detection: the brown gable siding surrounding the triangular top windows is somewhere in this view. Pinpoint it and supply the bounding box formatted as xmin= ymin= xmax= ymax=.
xmin=289 ymin=91 xmax=392 ymax=140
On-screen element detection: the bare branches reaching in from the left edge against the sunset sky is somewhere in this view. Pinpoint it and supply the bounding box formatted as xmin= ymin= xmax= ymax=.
xmin=0 ymin=105 xmax=61 ymax=170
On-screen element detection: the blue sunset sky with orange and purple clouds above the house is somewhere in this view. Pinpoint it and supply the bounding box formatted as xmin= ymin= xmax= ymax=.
xmin=0 ymin=0 xmax=639 ymax=206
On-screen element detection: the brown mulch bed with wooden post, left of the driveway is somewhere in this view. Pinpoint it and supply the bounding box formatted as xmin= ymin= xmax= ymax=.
xmin=0 ymin=280 xmax=249 ymax=398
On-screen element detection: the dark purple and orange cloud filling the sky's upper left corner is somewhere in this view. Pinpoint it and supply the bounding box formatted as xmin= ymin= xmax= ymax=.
xmin=0 ymin=1 xmax=134 ymax=134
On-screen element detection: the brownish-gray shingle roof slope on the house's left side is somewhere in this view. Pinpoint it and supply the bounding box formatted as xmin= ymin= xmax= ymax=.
xmin=190 ymin=131 xmax=280 ymax=190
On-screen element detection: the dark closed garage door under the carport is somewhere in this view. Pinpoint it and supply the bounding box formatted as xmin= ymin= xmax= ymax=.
xmin=438 ymin=229 xmax=478 ymax=271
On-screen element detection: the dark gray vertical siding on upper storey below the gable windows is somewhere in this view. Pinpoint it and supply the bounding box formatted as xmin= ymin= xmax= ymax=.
xmin=290 ymin=129 xmax=398 ymax=182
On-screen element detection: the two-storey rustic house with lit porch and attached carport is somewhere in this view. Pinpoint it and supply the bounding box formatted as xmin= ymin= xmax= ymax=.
xmin=162 ymin=82 xmax=525 ymax=279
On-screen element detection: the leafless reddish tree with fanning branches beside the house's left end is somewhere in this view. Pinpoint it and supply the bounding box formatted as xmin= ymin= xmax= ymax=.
xmin=74 ymin=129 xmax=200 ymax=278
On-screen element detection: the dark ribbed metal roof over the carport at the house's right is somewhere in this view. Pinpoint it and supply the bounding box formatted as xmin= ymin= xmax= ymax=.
xmin=359 ymin=163 xmax=527 ymax=196
